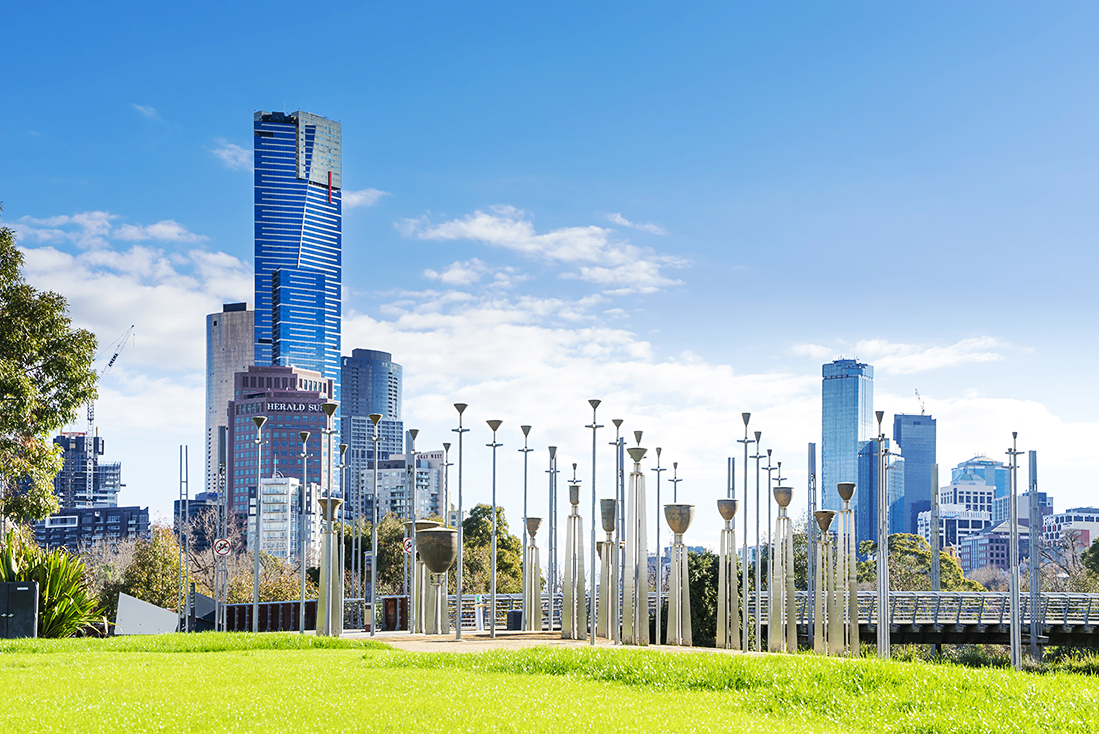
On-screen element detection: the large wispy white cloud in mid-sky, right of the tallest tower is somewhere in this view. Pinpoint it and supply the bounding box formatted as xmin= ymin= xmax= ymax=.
xmin=398 ymin=207 xmax=688 ymax=293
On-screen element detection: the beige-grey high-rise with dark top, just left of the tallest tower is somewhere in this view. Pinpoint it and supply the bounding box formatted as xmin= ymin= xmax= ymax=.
xmin=206 ymin=303 xmax=256 ymax=494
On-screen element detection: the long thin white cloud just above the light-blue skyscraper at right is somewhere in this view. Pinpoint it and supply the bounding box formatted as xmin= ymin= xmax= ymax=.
xmin=788 ymin=336 xmax=1004 ymax=375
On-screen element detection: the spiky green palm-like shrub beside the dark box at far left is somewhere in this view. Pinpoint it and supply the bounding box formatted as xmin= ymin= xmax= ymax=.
xmin=0 ymin=531 xmax=100 ymax=637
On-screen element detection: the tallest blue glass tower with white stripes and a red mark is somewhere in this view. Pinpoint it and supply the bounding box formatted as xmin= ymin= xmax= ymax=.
xmin=254 ymin=111 xmax=343 ymax=400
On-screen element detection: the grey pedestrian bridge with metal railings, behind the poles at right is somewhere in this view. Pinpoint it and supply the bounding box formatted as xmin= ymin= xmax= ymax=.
xmin=748 ymin=591 xmax=1099 ymax=647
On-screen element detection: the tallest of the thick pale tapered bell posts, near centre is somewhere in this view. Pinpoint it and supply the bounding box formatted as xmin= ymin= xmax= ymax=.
xmin=622 ymin=431 xmax=648 ymax=645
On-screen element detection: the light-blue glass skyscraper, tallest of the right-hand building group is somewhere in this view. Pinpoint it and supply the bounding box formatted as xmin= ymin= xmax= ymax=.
xmin=820 ymin=359 xmax=875 ymax=510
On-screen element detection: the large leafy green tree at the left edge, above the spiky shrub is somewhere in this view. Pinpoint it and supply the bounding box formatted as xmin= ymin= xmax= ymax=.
xmin=0 ymin=215 xmax=96 ymax=522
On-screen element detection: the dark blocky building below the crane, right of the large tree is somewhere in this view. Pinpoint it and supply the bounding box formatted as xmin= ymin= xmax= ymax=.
xmin=54 ymin=432 xmax=123 ymax=510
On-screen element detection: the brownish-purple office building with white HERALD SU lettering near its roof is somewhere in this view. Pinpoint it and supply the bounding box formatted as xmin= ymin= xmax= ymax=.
xmin=226 ymin=365 xmax=340 ymax=530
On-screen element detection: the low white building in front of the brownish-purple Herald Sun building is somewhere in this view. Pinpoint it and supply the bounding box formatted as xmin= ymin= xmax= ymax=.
xmin=246 ymin=477 xmax=323 ymax=565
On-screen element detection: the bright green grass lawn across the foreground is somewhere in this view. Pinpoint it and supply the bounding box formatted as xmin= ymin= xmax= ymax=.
xmin=0 ymin=633 xmax=1099 ymax=732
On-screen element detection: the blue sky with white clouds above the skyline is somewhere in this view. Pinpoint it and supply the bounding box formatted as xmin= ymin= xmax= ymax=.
xmin=0 ymin=2 xmax=1099 ymax=540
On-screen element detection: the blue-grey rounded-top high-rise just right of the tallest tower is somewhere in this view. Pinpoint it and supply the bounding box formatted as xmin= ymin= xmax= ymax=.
xmin=340 ymin=349 xmax=406 ymax=518
